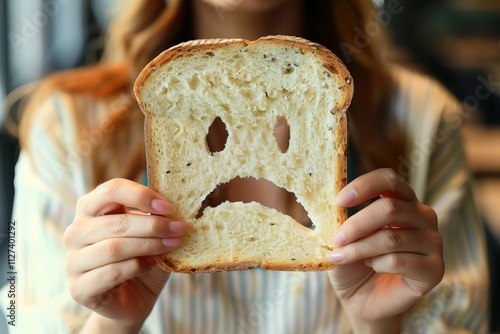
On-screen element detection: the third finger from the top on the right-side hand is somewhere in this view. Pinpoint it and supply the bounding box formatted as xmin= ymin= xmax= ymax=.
xmin=329 ymin=228 xmax=438 ymax=264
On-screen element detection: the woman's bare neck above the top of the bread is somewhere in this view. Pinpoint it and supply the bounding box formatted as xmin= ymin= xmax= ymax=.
xmin=192 ymin=0 xmax=305 ymax=40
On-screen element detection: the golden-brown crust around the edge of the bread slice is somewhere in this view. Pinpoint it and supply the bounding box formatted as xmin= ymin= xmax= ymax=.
xmin=134 ymin=35 xmax=354 ymax=273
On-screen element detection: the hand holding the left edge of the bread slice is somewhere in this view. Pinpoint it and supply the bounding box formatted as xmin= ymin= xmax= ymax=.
xmin=64 ymin=179 xmax=188 ymax=329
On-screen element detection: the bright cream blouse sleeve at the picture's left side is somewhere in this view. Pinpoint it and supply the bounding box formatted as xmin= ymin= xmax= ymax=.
xmin=0 ymin=92 xmax=92 ymax=333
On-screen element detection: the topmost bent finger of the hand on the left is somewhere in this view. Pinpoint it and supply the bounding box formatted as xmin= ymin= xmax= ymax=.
xmin=76 ymin=179 xmax=175 ymax=217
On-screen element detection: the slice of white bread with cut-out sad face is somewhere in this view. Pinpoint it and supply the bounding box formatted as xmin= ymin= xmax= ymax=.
xmin=135 ymin=36 xmax=353 ymax=273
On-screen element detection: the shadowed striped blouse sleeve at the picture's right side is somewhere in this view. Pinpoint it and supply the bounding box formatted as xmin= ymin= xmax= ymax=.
xmin=403 ymin=106 xmax=489 ymax=334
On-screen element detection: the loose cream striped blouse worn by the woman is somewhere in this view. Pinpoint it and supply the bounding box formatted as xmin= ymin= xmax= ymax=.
xmin=0 ymin=67 xmax=489 ymax=334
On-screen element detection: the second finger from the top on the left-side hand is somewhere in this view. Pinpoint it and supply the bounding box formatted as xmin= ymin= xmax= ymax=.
xmin=64 ymin=214 xmax=189 ymax=248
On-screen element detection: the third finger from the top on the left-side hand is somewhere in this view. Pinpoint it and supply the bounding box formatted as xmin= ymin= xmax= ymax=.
xmin=66 ymin=237 xmax=183 ymax=274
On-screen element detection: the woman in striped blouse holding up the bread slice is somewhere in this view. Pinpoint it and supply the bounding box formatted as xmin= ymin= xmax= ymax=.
xmin=3 ymin=0 xmax=488 ymax=333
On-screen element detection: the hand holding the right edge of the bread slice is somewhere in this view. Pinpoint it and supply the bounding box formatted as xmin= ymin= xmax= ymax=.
xmin=329 ymin=169 xmax=444 ymax=333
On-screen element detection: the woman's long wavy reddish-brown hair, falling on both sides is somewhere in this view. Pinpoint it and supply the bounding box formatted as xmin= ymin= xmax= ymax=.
xmin=21 ymin=0 xmax=405 ymax=188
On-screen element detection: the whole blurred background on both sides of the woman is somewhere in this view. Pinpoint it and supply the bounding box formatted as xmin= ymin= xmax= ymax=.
xmin=0 ymin=0 xmax=500 ymax=333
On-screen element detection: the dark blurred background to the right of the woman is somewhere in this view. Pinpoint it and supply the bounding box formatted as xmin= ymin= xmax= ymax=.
xmin=385 ymin=0 xmax=500 ymax=333
